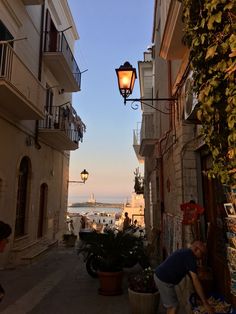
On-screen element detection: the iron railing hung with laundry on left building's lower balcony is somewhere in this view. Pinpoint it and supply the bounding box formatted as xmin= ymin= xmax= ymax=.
xmin=39 ymin=102 xmax=86 ymax=143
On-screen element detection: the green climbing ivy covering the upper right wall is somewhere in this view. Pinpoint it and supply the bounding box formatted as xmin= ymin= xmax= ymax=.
xmin=181 ymin=0 xmax=236 ymax=184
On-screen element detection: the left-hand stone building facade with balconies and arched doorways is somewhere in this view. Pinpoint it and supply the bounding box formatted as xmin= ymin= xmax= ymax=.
xmin=0 ymin=0 xmax=85 ymax=267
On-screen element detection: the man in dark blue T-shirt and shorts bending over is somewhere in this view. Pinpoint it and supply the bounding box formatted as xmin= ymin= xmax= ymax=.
xmin=154 ymin=241 xmax=214 ymax=314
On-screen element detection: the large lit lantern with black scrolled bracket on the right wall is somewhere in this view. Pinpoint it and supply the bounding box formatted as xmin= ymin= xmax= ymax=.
xmin=116 ymin=61 xmax=177 ymax=109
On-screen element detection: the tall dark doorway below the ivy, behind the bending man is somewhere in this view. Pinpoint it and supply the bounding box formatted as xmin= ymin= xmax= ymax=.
xmin=201 ymin=155 xmax=230 ymax=300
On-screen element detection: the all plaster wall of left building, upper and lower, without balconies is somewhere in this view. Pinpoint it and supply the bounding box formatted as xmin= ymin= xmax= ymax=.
xmin=0 ymin=0 xmax=78 ymax=268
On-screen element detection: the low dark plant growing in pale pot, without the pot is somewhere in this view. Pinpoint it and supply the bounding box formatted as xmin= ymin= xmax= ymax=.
xmin=128 ymin=267 xmax=157 ymax=293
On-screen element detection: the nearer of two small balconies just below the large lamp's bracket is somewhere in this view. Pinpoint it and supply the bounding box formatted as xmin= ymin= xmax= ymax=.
xmin=139 ymin=114 xmax=157 ymax=157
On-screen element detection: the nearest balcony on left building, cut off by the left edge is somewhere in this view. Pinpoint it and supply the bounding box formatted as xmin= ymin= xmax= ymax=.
xmin=0 ymin=42 xmax=45 ymax=120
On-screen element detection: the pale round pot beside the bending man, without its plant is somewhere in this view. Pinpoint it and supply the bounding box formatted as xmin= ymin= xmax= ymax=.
xmin=128 ymin=289 xmax=160 ymax=314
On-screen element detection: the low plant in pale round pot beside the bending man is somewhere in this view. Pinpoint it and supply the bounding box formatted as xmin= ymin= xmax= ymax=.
xmin=128 ymin=267 xmax=160 ymax=314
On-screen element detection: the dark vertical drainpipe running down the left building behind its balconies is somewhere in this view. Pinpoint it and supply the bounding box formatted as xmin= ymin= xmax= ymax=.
xmin=35 ymin=1 xmax=45 ymax=149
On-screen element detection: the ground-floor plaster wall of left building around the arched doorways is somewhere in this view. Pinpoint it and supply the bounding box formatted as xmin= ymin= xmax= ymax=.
xmin=0 ymin=118 xmax=69 ymax=258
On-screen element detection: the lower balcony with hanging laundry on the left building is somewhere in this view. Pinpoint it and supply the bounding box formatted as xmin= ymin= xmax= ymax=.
xmin=39 ymin=102 xmax=85 ymax=150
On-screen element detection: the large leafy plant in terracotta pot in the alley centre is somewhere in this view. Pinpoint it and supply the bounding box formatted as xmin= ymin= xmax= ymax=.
xmin=86 ymin=230 xmax=146 ymax=295
